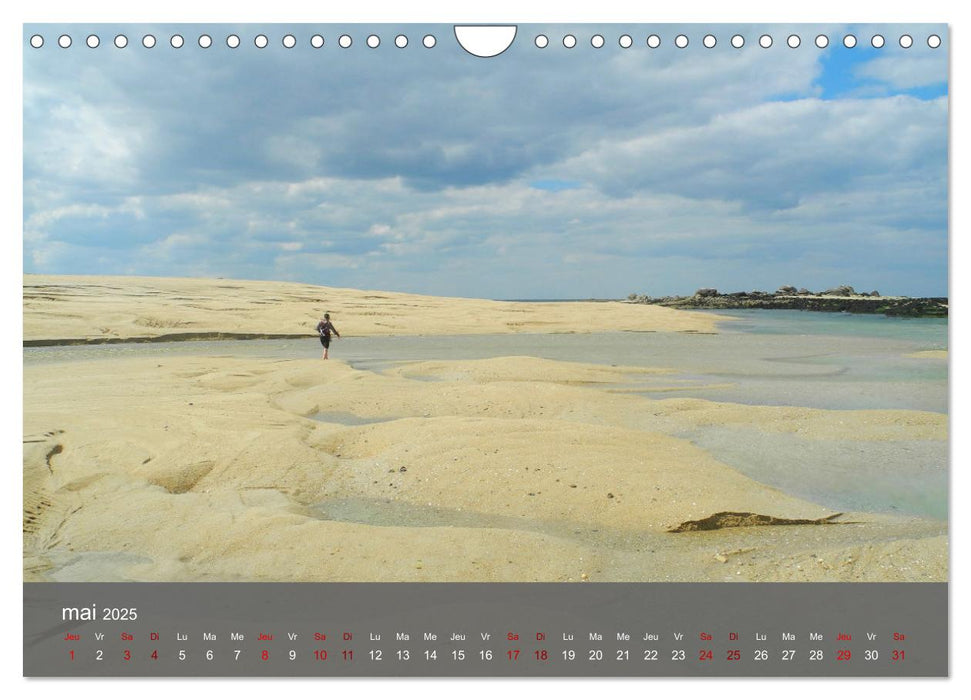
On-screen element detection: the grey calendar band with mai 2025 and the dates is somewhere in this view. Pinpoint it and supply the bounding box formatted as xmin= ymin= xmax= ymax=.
xmin=24 ymin=583 xmax=948 ymax=677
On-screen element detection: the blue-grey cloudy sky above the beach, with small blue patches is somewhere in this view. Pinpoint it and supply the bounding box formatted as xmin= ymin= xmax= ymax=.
xmin=23 ymin=25 xmax=948 ymax=299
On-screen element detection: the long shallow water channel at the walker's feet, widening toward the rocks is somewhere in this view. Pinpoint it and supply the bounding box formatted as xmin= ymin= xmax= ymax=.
xmin=24 ymin=311 xmax=948 ymax=413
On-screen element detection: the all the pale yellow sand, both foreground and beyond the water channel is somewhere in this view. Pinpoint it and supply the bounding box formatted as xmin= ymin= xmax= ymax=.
xmin=24 ymin=275 xmax=948 ymax=582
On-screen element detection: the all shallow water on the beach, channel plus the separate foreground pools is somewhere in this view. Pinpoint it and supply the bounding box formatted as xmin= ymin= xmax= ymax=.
xmin=24 ymin=310 xmax=948 ymax=527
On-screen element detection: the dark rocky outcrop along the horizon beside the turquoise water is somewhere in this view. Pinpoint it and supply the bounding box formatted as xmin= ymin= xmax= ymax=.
xmin=627 ymin=285 xmax=948 ymax=318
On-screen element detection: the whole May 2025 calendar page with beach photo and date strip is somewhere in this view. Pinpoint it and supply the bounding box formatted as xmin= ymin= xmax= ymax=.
xmin=22 ymin=23 xmax=950 ymax=678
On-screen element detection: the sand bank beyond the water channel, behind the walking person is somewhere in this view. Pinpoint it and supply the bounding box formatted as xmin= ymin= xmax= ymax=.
xmin=24 ymin=275 xmax=715 ymax=344
